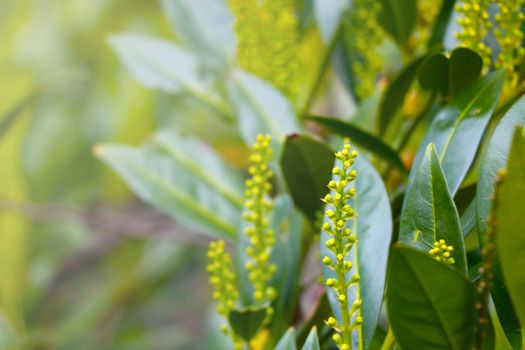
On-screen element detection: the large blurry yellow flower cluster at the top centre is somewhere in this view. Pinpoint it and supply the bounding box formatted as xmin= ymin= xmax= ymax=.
xmin=228 ymin=0 xmax=300 ymax=98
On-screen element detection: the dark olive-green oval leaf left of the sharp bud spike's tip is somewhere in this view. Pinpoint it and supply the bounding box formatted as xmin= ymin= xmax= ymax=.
xmin=280 ymin=134 xmax=335 ymax=222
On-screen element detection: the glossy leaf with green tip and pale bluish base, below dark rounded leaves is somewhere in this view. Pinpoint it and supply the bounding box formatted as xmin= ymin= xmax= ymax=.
xmin=404 ymin=71 xmax=504 ymax=197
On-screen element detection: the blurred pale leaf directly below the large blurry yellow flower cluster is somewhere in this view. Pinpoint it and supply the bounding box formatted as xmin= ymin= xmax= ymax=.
xmin=228 ymin=70 xmax=300 ymax=144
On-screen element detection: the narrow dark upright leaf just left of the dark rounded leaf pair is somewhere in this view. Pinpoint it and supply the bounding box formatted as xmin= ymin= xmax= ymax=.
xmin=379 ymin=56 xmax=424 ymax=135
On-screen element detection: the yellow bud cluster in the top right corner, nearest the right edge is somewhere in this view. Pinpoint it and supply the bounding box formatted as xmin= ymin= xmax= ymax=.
xmin=494 ymin=0 xmax=525 ymax=87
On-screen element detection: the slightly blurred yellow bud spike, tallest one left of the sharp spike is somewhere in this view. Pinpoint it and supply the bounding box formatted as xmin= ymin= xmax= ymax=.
xmin=243 ymin=135 xmax=276 ymax=302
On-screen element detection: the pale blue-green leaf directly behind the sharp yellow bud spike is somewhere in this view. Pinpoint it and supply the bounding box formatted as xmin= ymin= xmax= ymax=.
xmin=321 ymin=156 xmax=392 ymax=348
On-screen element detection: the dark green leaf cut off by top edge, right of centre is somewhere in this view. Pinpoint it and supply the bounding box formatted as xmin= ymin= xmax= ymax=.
xmin=379 ymin=0 xmax=417 ymax=47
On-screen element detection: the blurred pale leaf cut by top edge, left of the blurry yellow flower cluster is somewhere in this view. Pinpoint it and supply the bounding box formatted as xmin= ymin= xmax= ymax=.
xmin=161 ymin=0 xmax=235 ymax=67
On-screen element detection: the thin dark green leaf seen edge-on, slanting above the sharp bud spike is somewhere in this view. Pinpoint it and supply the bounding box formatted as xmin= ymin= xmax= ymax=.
xmin=308 ymin=116 xmax=406 ymax=172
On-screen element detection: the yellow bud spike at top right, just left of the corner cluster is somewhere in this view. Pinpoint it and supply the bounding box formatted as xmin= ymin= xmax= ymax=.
xmin=456 ymin=0 xmax=492 ymax=68
